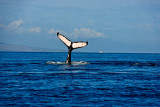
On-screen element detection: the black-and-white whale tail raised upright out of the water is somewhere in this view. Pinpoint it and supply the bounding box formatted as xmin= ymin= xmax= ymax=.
xmin=57 ymin=32 xmax=88 ymax=64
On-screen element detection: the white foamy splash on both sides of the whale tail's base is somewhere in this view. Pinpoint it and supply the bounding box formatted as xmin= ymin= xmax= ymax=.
xmin=46 ymin=61 xmax=89 ymax=65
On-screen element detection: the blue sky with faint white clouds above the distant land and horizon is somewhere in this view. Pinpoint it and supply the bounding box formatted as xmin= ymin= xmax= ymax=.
xmin=0 ymin=0 xmax=160 ymax=53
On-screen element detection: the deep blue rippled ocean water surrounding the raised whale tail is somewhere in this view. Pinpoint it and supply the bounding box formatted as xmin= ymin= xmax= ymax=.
xmin=0 ymin=52 xmax=160 ymax=107
